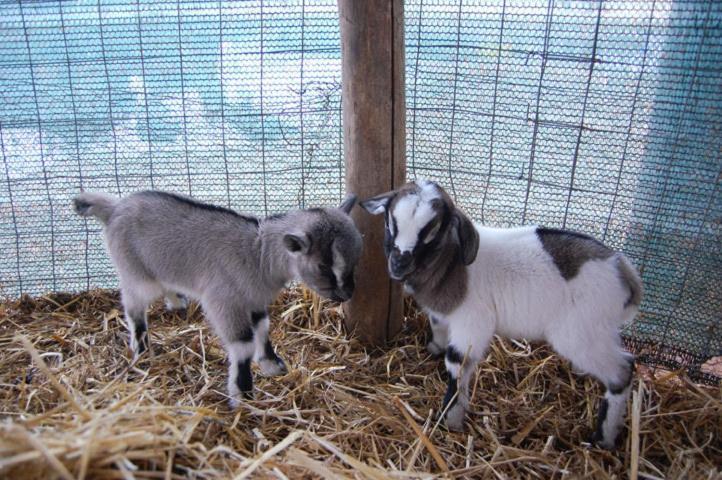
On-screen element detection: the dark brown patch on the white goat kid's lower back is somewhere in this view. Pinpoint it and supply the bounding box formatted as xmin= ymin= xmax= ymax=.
xmin=536 ymin=227 xmax=614 ymax=280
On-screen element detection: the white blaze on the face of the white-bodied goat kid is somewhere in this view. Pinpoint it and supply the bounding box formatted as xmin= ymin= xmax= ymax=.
xmin=389 ymin=182 xmax=440 ymax=252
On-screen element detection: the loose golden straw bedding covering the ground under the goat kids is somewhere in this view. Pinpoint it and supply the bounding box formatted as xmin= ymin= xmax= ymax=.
xmin=0 ymin=288 xmax=722 ymax=479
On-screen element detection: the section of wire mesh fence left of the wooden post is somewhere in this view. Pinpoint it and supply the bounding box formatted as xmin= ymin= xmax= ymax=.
xmin=0 ymin=0 xmax=343 ymax=296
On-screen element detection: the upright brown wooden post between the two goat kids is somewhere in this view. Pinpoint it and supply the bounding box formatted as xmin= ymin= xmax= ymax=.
xmin=338 ymin=0 xmax=406 ymax=345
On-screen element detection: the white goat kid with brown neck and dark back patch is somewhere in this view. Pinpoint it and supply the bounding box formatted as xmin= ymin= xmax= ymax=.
xmin=361 ymin=181 xmax=642 ymax=448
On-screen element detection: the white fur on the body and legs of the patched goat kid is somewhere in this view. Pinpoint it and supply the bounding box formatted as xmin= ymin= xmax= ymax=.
xmin=432 ymin=225 xmax=637 ymax=447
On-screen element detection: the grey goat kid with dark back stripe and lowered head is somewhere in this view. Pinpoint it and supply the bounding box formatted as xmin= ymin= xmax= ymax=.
xmin=74 ymin=191 xmax=362 ymax=403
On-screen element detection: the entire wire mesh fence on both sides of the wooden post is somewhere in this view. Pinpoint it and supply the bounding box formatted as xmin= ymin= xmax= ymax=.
xmin=0 ymin=0 xmax=722 ymax=381
